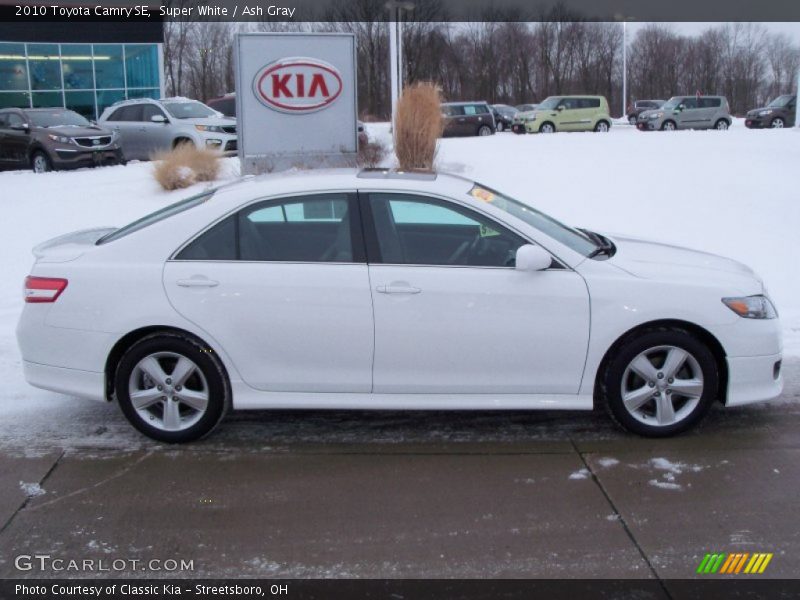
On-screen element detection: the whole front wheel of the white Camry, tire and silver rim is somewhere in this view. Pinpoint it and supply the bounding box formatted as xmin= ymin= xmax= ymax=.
xmin=601 ymin=328 xmax=719 ymax=437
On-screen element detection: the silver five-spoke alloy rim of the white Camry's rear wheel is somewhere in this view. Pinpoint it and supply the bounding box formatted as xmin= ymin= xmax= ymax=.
xmin=128 ymin=352 xmax=209 ymax=431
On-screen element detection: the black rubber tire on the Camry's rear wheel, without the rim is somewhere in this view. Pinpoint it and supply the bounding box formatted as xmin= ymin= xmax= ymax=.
xmin=114 ymin=332 xmax=231 ymax=444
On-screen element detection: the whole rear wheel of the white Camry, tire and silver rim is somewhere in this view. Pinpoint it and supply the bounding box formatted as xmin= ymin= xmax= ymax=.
xmin=114 ymin=333 xmax=229 ymax=443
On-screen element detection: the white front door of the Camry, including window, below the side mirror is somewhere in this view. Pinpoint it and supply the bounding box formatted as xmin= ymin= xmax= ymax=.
xmin=362 ymin=193 xmax=589 ymax=394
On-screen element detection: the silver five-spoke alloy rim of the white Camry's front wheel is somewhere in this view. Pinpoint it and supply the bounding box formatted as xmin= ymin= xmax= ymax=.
xmin=622 ymin=346 xmax=703 ymax=427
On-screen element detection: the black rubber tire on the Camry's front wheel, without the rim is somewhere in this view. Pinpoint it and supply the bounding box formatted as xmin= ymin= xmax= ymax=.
xmin=599 ymin=328 xmax=720 ymax=437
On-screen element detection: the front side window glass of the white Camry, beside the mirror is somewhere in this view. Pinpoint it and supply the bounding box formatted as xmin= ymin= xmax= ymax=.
xmin=369 ymin=193 xmax=527 ymax=267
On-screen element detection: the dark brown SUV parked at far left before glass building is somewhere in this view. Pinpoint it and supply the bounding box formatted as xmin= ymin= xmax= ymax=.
xmin=0 ymin=108 xmax=123 ymax=173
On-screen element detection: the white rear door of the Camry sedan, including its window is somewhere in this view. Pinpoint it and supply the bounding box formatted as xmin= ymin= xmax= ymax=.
xmin=164 ymin=193 xmax=374 ymax=392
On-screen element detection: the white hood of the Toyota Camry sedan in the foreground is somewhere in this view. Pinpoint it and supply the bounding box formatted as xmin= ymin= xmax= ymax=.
xmin=604 ymin=234 xmax=764 ymax=294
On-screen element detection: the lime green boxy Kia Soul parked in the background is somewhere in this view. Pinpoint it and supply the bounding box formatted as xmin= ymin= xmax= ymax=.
xmin=525 ymin=96 xmax=611 ymax=133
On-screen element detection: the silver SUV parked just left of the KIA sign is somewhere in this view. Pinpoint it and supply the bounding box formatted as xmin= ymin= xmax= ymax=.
xmin=98 ymin=98 xmax=236 ymax=160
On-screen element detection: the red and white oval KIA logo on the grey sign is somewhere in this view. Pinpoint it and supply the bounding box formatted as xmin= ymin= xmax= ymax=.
xmin=253 ymin=57 xmax=342 ymax=114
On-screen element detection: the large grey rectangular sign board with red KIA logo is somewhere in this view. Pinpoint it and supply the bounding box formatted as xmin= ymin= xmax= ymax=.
xmin=236 ymin=33 xmax=358 ymax=173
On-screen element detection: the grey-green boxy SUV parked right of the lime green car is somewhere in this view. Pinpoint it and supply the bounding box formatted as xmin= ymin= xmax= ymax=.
xmin=636 ymin=96 xmax=733 ymax=131
